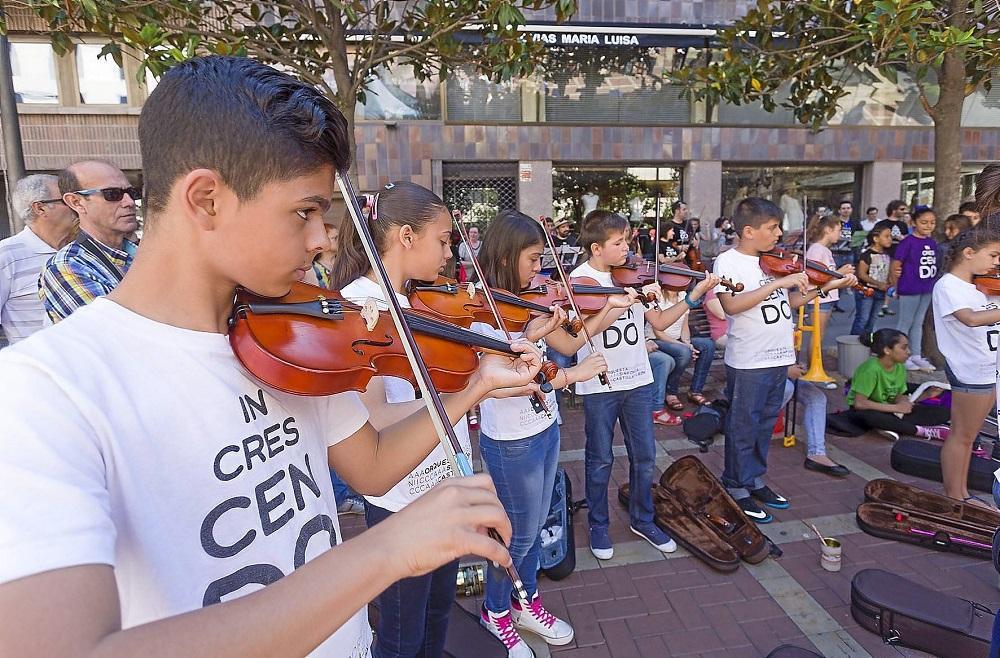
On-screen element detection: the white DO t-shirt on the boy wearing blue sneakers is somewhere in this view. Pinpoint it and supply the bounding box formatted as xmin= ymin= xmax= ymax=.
xmin=570 ymin=263 xmax=653 ymax=395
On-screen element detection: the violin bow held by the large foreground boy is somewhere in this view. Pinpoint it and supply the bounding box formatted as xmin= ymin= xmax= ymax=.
xmin=337 ymin=171 xmax=528 ymax=604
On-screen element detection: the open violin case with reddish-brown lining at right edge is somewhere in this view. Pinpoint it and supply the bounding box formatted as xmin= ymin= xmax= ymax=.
xmin=857 ymin=478 xmax=1000 ymax=560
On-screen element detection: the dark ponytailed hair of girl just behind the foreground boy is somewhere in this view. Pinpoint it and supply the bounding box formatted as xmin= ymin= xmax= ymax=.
xmin=330 ymin=182 xmax=448 ymax=290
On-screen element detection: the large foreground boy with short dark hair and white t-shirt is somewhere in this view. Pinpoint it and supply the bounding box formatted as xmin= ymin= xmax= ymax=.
xmin=0 ymin=57 xmax=540 ymax=657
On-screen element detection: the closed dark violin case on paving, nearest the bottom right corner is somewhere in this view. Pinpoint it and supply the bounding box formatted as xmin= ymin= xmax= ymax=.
xmin=851 ymin=569 xmax=996 ymax=658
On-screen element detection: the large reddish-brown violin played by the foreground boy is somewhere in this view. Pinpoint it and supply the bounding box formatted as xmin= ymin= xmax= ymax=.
xmin=229 ymin=283 xmax=555 ymax=395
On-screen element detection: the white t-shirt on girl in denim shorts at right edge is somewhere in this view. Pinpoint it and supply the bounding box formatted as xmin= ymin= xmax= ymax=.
xmin=931 ymin=273 xmax=1000 ymax=384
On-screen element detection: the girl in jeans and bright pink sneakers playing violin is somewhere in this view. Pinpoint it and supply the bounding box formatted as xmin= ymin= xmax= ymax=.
xmin=472 ymin=210 xmax=612 ymax=658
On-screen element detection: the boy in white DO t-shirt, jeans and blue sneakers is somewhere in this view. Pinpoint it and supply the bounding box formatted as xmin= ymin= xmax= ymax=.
xmin=572 ymin=210 xmax=719 ymax=560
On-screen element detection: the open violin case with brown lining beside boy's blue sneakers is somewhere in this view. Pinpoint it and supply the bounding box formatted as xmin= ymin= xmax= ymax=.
xmin=618 ymin=455 xmax=781 ymax=571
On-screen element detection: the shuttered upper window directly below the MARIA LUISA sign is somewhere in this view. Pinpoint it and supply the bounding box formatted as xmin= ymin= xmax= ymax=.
xmin=543 ymin=47 xmax=699 ymax=124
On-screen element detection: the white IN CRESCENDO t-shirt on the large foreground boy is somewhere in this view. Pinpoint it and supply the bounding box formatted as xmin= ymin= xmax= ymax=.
xmin=0 ymin=298 xmax=371 ymax=657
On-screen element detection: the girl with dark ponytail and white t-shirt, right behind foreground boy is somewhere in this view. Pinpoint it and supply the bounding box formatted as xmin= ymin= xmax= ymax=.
xmin=331 ymin=182 xmax=480 ymax=657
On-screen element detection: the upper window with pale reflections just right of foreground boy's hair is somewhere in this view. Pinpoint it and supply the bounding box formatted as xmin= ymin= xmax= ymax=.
xmin=355 ymin=64 xmax=441 ymax=120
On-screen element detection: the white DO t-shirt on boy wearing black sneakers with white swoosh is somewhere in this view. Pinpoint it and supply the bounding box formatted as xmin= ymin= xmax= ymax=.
xmin=713 ymin=249 xmax=795 ymax=370
